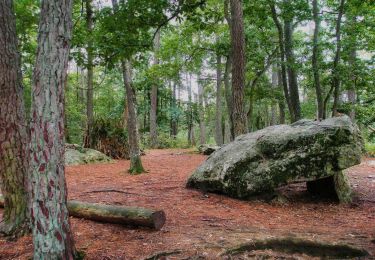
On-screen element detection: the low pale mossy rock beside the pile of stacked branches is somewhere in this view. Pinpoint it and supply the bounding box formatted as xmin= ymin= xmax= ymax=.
xmin=65 ymin=144 xmax=112 ymax=165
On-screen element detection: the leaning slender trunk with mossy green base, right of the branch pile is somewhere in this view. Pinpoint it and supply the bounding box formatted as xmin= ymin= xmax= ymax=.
xmin=121 ymin=60 xmax=145 ymax=174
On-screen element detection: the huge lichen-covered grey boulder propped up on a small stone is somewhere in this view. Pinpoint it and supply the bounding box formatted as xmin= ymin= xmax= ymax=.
xmin=187 ymin=116 xmax=363 ymax=202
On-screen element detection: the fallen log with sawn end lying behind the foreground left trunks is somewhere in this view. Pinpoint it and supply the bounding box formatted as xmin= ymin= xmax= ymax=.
xmin=0 ymin=195 xmax=166 ymax=230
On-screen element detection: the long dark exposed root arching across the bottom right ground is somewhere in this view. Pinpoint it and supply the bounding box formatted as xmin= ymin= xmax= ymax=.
xmin=222 ymin=238 xmax=369 ymax=259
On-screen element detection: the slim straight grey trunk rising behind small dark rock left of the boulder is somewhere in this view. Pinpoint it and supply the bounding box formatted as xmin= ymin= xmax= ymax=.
xmin=215 ymin=54 xmax=224 ymax=146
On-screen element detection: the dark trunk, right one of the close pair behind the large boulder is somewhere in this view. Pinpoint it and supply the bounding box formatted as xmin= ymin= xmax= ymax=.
xmin=284 ymin=5 xmax=301 ymax=122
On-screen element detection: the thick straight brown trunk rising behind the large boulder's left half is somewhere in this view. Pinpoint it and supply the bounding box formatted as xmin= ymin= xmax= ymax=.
xmin=230 ymin=0 xmax=247 ymax=137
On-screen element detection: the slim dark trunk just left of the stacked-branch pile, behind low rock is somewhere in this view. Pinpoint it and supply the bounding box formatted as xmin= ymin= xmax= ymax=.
xmin=84 ymin=0 xmax=94 ymax=148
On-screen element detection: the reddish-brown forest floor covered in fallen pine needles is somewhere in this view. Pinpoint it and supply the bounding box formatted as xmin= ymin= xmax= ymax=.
xmin=0 ymin=150 xmax=375 ymax=259
